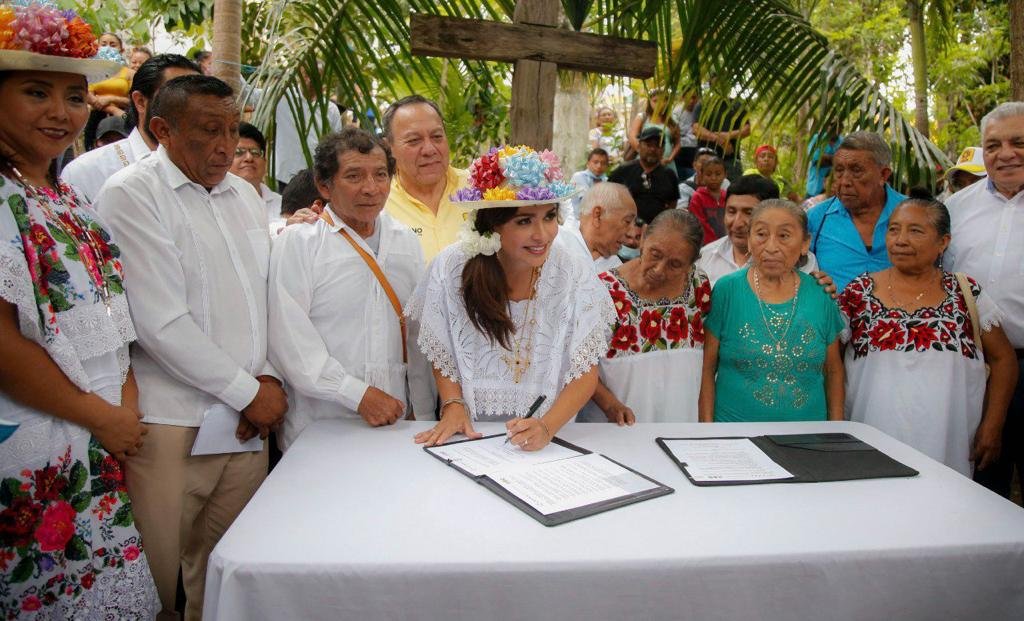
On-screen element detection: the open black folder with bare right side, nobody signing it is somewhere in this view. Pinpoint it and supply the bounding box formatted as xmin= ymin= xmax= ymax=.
xmin=655 ymin=433 xmax=918 ymax=486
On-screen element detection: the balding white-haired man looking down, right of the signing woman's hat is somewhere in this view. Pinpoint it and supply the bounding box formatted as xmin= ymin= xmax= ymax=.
xmin=556 ymin=181 xmax=637 ymax=274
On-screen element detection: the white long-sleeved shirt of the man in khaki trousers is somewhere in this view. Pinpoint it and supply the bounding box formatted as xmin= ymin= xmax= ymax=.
xmin=96 ymin=147 xmax=274 ymax=427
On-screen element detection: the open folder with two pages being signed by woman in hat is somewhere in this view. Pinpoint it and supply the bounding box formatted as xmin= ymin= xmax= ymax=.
xmin=424 ymin=433 xmax=674 ymax=526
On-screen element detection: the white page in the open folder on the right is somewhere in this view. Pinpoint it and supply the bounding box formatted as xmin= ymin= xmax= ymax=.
xmin=664 ymin=438 xmax=793 ymax=482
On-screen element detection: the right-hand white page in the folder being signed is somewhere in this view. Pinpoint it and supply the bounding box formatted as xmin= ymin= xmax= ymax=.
xmin=490 ymin=453 xmax=657 ymax=515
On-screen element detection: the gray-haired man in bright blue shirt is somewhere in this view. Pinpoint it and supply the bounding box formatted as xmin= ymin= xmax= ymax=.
xmin=807 ymin=131 xmax=906 ymax=291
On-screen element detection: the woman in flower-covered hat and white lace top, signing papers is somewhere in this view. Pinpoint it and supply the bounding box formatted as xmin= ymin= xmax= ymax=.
xmin=408 ymin=147 xmax=614 ymax=450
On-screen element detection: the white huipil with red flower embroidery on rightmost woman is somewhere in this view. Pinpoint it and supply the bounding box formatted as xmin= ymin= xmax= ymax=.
xmin=839 ymin=273 xmax=1001 ymax=475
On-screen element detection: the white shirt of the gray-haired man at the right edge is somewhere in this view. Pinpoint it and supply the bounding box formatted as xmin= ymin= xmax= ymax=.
xmin=942 ymin=179 xmax=1024 ymax=348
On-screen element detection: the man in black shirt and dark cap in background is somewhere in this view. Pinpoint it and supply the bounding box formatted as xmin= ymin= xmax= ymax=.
xmin=608 ymin=127 xmax=679 ymax=222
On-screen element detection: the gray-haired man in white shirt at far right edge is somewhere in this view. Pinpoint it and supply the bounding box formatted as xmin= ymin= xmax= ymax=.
xmin=943 ymin=101 xmax=1024 ymax=497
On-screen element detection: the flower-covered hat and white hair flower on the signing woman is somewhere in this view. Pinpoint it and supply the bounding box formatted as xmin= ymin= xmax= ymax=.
xmin=449 ymin=144 xmax=581 ymax=256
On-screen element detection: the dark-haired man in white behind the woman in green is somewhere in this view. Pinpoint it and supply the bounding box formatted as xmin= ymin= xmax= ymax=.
xmin=696 ymin=174 xmax=818 ymax=287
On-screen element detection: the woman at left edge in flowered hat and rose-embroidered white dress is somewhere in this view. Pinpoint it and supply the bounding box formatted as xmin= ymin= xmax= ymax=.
xmin=0 ymin=4 xmax=157 ymax=619
